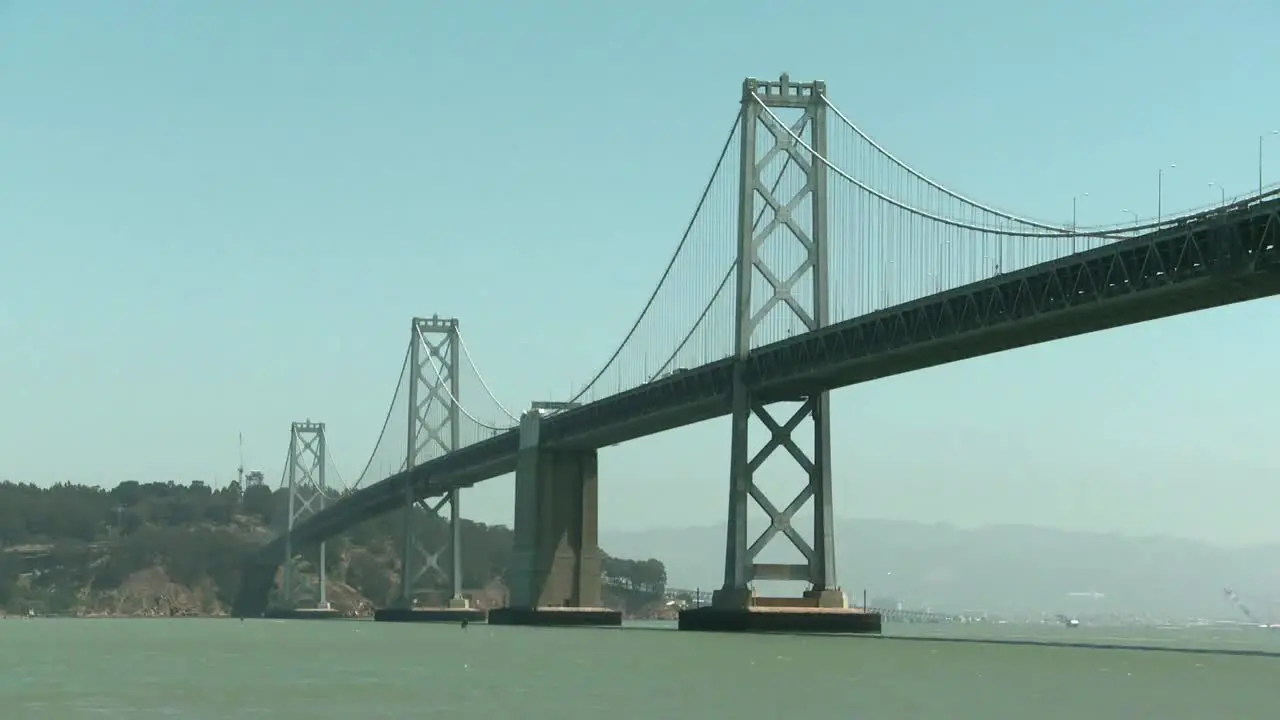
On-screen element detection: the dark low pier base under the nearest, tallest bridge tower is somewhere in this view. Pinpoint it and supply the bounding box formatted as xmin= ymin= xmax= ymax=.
xmin=678 ymin=606 xmax=881 ymax=634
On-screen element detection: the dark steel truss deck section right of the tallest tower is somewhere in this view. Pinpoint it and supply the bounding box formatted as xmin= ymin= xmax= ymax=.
xmin=746 ymin=200 xmax=1280 ymax=397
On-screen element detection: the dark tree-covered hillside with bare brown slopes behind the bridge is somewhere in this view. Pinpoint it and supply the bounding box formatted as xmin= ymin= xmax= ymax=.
xmin=0 ymin=478 xmax=666 ymax=615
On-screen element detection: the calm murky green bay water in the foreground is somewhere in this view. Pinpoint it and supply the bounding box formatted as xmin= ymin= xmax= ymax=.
xmin=0 ymin=619 xmax=1280 ymax=720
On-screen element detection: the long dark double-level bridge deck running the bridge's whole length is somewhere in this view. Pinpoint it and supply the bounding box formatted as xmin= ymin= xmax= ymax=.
xmin=275 ymin=199 xmax=1280 ymax=552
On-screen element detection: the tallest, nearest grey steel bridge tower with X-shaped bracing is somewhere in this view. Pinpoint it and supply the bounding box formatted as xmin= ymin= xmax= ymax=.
xmin=716 ymin=74 xmax=847 ymax=606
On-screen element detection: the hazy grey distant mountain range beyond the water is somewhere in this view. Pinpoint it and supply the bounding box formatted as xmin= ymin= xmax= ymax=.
xmin=600 ymin=519 xmax=1280 ymax=623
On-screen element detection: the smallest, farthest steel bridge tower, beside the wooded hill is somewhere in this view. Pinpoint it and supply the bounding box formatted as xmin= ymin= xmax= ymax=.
xmin=280 ymin=420 xmax=329 ymax=610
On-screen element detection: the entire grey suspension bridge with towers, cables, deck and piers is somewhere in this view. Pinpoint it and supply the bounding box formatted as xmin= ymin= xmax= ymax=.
xmin=236 ymin=76 xmax=1280 ymax=630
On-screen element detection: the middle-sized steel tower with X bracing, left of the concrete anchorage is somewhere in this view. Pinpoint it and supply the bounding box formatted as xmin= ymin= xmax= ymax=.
xmin=399 ymin=315 xmax=465 ymax=607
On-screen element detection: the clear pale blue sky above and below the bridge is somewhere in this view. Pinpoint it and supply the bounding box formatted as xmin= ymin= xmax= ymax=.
xmin=0 ymin=0 xmax=1280 ymax=543
